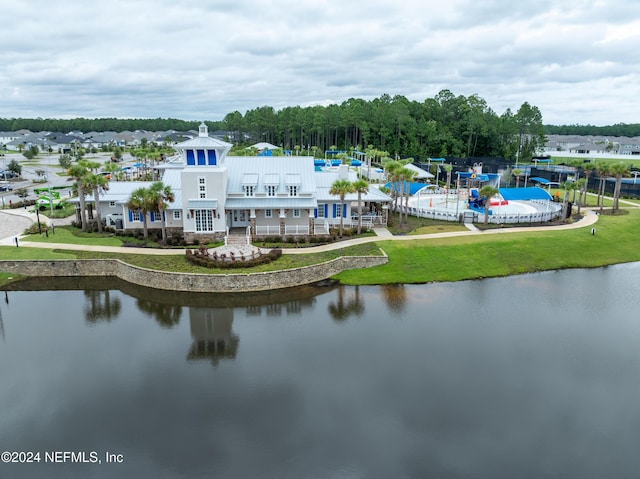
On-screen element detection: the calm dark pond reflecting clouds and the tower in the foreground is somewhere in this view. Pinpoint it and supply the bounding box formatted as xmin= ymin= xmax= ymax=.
xmin=0 ymin=263 xmax=640 ymax=479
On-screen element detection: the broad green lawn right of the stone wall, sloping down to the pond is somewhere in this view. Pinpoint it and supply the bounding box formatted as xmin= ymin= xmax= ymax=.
xmin=337 ymin=210 xmax=640 ymax=285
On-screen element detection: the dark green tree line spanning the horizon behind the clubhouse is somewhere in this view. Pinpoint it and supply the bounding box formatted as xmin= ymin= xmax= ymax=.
xmin=10 ymin=90 xmax=640 ymax=161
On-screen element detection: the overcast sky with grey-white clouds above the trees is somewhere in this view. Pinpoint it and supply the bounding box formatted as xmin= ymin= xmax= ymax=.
xmin=0 ymin=0 xmax=640 ymax=125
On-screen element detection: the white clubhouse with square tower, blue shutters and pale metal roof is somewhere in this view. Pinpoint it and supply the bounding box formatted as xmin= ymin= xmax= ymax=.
xmin=87 ymin=123 xmax=392 ymax=241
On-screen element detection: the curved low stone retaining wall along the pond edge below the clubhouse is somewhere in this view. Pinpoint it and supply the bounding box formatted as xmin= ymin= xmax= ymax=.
xmin=0 ymin=255 xmax=388 ymax=293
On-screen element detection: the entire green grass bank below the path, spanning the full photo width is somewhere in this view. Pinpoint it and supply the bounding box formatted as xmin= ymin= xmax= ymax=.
xmin=0 ymin=209 xmax=640 ymax=284
